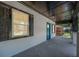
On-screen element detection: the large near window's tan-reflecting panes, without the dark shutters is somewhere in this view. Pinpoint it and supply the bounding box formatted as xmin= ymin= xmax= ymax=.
xmin=12 ymin=9 xmax=29 ymax=37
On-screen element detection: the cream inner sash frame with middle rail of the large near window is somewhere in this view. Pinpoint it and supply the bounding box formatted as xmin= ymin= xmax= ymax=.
xmin=11 ymin=8 xmax=30 ymax=37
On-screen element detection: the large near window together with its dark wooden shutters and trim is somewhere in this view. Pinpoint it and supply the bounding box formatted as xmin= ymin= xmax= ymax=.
xmin=0 ymin=3 xmax=34 ymax=41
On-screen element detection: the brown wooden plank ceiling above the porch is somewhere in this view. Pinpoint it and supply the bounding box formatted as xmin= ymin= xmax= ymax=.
xmin=20 ymin=1 xmax=71 ymax=22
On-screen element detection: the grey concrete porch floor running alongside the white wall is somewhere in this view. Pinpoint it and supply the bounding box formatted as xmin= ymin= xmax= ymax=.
xmin=13 ymin=37 xmax=76 ymax=57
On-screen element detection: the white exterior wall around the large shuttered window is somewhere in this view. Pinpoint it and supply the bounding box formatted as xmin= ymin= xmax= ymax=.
xmin=0 ymin=1 xmax=55 ymax=56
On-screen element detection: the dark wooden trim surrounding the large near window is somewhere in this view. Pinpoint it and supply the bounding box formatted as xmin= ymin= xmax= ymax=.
xmin=11 ymin=7 xmax=34 ymax=39
